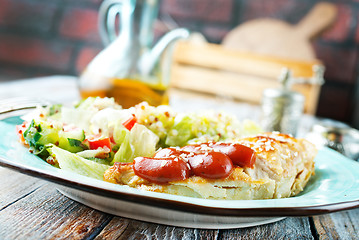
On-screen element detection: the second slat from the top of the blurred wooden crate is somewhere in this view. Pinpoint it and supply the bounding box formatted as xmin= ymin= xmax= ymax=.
xmin=171 ymin=64 xmax=320 ymax=115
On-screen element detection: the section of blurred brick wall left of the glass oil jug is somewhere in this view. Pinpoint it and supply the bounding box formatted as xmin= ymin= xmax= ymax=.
xmin=0 ymin=0 xmax=102 ymax=79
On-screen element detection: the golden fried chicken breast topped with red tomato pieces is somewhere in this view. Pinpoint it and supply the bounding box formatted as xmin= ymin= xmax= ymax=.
xmin=104 ymin=132 xmax=317 ymax=200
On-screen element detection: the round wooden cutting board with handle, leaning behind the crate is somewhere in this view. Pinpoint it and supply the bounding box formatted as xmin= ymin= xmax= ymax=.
xmin=222 ymin=2 xmax=337 ymax=61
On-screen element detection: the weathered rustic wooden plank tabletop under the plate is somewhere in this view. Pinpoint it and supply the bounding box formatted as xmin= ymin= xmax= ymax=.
xmin=0 ymin=76 xmax=359 ymax=239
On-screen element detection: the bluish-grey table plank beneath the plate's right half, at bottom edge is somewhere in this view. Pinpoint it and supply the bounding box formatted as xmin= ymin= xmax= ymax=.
xmin=221 ymin=217 xmax=314 ymax=240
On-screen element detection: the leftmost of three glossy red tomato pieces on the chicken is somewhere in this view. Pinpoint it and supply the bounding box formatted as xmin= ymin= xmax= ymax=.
xmin=133 ymin=157 xmax=190 ymax=183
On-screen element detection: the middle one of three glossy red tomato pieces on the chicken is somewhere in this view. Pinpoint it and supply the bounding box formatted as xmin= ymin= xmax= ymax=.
xmin=188 ymin=151 xmax=233 ymax=179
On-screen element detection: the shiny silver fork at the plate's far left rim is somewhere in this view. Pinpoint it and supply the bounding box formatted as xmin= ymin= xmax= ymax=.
xmin=0 ymin=97 xmax=50 ymax=114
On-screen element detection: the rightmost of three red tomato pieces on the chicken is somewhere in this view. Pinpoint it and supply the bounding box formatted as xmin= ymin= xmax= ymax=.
xmin=211 ymin=143 xmax=256 ymax=168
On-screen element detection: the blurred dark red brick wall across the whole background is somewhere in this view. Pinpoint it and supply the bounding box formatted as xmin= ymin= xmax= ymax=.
xmin=0 ymin=0 xmax=359 ymax=127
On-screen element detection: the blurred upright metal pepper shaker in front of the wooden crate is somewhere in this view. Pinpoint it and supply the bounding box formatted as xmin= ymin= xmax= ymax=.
xmin=262 ymin=69 xmax=305 ymax=136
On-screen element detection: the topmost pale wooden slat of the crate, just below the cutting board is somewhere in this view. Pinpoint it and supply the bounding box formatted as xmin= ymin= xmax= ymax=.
xmin=174 ymin=41 xmax=321 ymax=79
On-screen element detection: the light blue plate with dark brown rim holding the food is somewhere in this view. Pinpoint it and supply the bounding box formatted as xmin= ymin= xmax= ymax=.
xmin=0 ymin=117 xmax=359 ymax=229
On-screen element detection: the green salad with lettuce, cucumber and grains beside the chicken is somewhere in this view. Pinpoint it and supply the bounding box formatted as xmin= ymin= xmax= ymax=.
xmin=17 ymin=97 xmax=261 ymax=180
